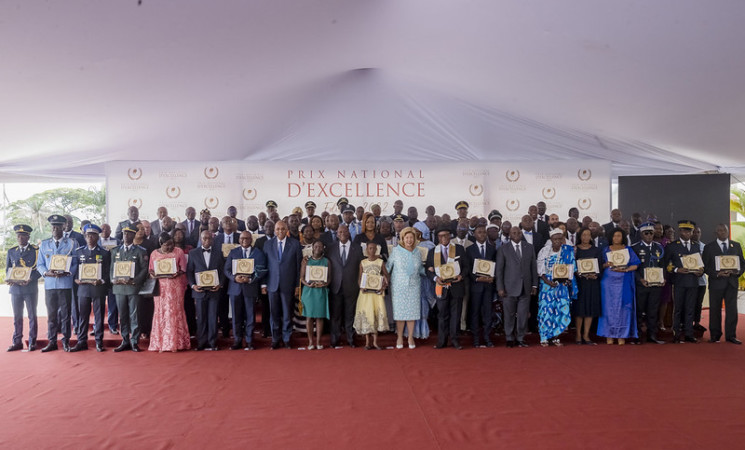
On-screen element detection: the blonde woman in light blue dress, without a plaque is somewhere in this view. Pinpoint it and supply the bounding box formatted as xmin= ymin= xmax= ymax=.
xmin=386 ymin=227 xmax=425 ymax=348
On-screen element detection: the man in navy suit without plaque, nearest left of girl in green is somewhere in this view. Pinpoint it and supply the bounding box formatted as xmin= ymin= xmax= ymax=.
xmin=264 ymin=220 xmax=302 ymax=350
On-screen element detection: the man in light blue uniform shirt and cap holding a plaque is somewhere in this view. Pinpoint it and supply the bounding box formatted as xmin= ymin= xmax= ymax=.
xmin=37 ymin=214 xmax=77 ymax=353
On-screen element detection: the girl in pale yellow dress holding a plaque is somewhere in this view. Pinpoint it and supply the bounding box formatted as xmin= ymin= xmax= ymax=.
xmin=354 ymin=242 xmax=388 ymax=350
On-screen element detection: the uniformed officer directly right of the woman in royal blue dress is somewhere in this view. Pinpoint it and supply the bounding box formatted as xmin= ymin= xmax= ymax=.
xmin=631 ymin=222 xmax=665 ymax=344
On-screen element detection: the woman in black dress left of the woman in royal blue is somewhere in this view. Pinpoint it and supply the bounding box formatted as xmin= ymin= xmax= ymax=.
xmin=572 ymin=228 xmax=603 ymax=345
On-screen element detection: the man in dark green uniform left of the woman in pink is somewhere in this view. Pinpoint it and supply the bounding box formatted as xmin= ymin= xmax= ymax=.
xmin=109 ymin=225 xmax=149 ymax=352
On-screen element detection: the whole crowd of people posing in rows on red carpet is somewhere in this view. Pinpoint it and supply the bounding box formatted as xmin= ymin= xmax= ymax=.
xmin=6 ymin=198 xmax=745 ymax=352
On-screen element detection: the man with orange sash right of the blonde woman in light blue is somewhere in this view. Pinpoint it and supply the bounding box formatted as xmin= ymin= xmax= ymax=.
xmin=426 ymin=227 xmax=469 ymax=350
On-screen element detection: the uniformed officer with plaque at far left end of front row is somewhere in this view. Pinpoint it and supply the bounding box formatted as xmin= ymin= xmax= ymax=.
xmin=5 ymin=225 xmax=41 ymax=352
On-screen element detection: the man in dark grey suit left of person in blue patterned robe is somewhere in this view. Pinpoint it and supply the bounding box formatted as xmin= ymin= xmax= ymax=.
xmin=497 ymin=227 xmax=538 ymax=348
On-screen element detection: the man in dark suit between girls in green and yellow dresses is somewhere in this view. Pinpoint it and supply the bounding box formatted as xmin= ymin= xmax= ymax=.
xmin=326 ymin=225 xmax=362 ymax=347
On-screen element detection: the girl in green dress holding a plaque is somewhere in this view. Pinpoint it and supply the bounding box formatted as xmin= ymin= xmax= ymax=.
xmin=300 ymin=241 xmax=329 ymax=350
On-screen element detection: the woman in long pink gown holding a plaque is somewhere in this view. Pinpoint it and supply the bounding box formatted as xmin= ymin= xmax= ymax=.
xmin=148 ymin=233 xmax=191 ymax=352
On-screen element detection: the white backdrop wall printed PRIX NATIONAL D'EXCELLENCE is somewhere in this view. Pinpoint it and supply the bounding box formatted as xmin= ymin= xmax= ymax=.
xmin=106 ymin=161 xmax=611 ymax=223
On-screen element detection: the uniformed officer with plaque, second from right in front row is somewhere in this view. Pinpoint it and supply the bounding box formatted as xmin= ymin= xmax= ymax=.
xmin=665 ymin=220 xmax=704 ymax=343
